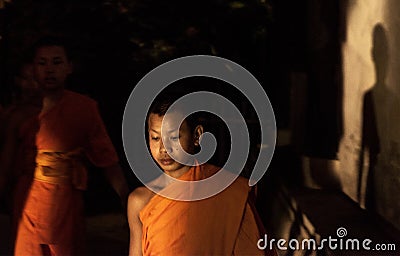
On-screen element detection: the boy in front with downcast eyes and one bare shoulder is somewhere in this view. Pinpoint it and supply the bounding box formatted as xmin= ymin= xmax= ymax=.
xmin=128 ymin=91 xmax=275 ymax=256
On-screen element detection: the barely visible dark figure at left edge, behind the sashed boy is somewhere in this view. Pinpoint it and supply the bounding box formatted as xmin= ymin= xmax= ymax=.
xmin=0 ymin=58 xmax=42 ymax=256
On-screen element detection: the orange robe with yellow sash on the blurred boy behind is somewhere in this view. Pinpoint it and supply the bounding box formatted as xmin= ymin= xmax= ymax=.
xmin=15 ymin=90 xmax=118 ymax=255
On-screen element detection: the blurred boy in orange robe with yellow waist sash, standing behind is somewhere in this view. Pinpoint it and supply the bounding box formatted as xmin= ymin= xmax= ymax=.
xmin=1 ymin=36 xmax=128 ymax=255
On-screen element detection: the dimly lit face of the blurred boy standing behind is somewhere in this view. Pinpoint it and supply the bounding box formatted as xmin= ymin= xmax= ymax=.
xmin=33 ymin=46 xmax=72 ymax=90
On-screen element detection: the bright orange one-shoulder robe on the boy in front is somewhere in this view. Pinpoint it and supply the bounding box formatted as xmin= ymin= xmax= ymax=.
xmin=140 ymin=164 xmax=273 ymax=256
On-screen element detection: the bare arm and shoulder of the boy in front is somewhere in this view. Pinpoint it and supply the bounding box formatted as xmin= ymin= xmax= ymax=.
xmin=127 ymin=187 xmax=151 ymax=256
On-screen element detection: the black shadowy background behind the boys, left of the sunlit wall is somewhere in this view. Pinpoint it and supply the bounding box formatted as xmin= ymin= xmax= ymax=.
xmin=0 ymin=0 xmax=341 ymax=212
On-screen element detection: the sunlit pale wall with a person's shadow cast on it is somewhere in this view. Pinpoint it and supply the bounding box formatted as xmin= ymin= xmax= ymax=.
xmin=339 ymin=0 xmax=400 ymax=228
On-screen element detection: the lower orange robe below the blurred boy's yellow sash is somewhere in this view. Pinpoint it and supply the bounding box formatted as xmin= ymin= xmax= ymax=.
xmin=15 ymin=180 xmax=84 ymax=255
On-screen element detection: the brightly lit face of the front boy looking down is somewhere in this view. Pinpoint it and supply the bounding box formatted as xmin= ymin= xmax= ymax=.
xmin=148 ymin=113 xmax=195 ymax=178
